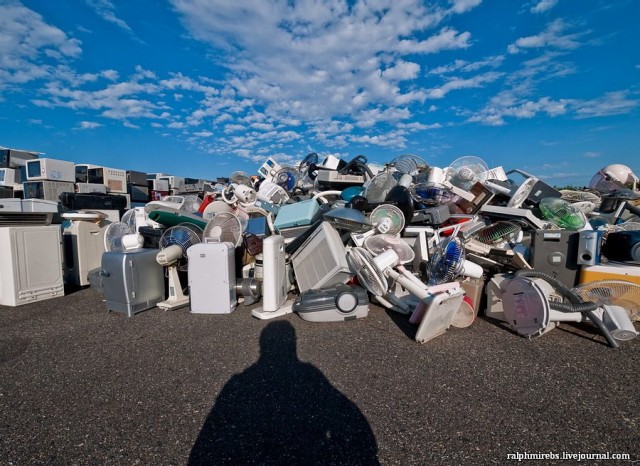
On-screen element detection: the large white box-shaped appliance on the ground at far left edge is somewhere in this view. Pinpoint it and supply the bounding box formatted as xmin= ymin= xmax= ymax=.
xmin=0 ymin=225 xmax=64 ymax=306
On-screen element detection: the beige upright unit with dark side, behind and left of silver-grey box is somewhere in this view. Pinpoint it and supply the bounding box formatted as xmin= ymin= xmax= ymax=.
xmin=62 ymin=213 xmax=106 ymax=286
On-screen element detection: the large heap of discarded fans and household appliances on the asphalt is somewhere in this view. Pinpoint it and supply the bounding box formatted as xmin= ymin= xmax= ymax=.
xmin=0 ymin=153 xmax=640 ymax=347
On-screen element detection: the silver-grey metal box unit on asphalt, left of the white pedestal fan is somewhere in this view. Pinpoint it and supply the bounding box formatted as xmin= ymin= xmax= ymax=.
xmin=100 ymin=249 xmax=164 ymax=317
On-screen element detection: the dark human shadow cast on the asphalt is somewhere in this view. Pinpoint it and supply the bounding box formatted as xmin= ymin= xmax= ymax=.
xmin=189 ymin=321 xmax=379 ymax=466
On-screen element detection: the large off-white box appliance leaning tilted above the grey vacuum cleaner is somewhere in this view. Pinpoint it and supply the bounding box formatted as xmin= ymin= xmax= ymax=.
xmin=291 ymin=222 xmax=351 ymax=293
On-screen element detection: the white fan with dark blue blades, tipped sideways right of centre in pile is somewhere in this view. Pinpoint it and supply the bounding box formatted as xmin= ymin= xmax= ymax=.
xmin=428 ymin=237 xmax=483 ymax=285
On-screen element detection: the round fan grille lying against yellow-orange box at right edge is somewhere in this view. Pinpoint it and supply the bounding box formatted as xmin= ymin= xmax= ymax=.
xmin=571 ymin=280 xmax=640 ymax=321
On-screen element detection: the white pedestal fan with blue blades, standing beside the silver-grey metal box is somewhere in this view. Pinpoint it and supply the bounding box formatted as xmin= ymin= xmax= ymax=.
xmin=156 ymin=224 xmax=202 ymax=311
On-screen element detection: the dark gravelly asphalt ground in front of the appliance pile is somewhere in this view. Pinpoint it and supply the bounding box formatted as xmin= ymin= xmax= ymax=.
xmin=0 ymin=289 xmax=640 ymax=465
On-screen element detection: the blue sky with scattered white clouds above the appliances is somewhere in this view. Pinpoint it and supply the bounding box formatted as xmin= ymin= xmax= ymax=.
xmin=0 ymin=0 xmax=640 ymax=185
